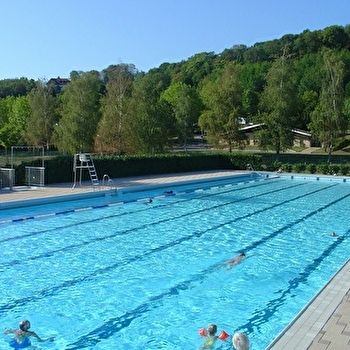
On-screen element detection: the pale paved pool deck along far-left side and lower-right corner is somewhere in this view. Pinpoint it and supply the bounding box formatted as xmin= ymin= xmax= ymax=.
xmin=0 ymin=170 xmax=350 ymax=350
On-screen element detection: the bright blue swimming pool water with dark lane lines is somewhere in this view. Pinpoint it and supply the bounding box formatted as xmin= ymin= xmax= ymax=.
xmin=0 ymin=177 xmax=350 ymax=350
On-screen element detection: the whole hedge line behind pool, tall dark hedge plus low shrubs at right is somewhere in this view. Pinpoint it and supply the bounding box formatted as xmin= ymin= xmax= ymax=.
xmin=15 ymin=152 xmax=350 ymax=185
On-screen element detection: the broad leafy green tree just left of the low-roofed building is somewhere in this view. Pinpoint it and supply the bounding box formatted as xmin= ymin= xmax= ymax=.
xmin=198 ymin=62 xmax=245 ymax=152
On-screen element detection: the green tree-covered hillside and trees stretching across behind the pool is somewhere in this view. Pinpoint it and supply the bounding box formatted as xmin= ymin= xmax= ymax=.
xmin=0 ymin=25 xmax=350 ymax=154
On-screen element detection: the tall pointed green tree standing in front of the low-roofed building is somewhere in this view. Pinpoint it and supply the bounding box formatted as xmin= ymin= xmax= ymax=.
xmin=257 ymin=49 xmax=297 ymax=160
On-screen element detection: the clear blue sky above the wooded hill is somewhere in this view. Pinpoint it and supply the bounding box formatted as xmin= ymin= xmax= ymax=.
xmin=0 ymin=0 xmax=350 ymax=80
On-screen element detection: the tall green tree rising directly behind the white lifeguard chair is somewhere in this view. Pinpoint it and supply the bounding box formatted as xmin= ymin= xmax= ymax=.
xmin=54 ymin=71 xmax=102 ymax=153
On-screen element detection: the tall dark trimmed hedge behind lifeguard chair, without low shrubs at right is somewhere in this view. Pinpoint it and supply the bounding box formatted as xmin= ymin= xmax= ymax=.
xmin=15 ymin=152 xmax=261 ymax=185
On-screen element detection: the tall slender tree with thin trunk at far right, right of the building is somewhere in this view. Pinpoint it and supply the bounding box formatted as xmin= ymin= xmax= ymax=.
xmin=309 ymin=49 xmax=348 ymax=162
